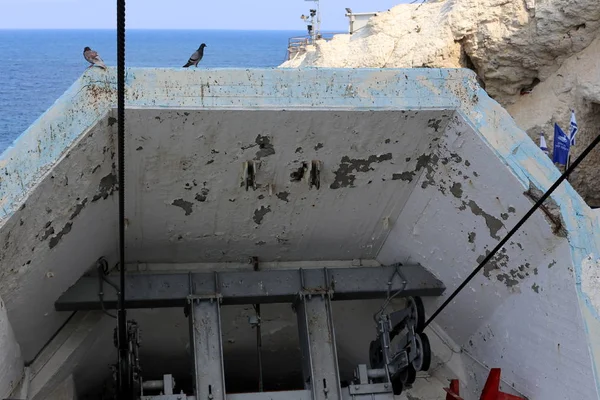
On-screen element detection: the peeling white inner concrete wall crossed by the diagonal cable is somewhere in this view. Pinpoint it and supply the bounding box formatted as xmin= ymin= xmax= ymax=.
xmin=378 ymin=114 xmax=596 ymax=399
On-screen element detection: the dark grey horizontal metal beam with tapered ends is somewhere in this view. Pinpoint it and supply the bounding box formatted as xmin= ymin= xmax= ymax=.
xmin=54 ymin=265 xmax=445 ymax=311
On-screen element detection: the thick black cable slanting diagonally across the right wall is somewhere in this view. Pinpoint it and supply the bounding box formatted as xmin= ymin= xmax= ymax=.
xmin=425 ymin=131 xmax=600 ymax=326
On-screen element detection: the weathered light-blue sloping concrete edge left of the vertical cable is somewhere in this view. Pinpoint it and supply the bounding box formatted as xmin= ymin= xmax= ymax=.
xmin=0 ymin=73 xmax=110 ymax=225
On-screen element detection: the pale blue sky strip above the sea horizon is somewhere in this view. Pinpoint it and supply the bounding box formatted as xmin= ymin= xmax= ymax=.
xmin=0 ymin=0 xmax=408 ymax=31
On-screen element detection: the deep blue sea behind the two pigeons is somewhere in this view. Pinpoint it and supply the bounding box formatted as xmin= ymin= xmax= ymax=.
xmin=0 ymin=30 xmax=305 ymax=153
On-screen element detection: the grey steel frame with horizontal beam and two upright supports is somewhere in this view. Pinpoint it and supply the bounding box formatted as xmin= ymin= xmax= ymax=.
xmin=55 ymin=264 xmax=445 ymax=400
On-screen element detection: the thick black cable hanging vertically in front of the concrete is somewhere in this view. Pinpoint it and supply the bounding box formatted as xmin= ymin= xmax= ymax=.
xmin=117 ymin=0 xmax=133 ymax=400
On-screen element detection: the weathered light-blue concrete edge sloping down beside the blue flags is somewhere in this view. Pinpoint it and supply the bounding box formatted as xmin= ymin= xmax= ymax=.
xmin=458 ymin=80 xmax=600 ymax=397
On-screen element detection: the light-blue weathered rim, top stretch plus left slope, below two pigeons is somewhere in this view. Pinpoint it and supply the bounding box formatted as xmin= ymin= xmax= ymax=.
xmin=0 ymin=68 xmax=465 ymax=224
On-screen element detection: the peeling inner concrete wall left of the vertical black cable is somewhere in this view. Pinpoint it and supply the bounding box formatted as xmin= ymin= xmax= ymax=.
xmin=0 ymin=117 xmax=118 ymax=361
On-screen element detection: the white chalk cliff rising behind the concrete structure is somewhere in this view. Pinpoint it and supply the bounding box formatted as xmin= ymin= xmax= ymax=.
xmin=281 ymin=0 xmax=600 ymax=206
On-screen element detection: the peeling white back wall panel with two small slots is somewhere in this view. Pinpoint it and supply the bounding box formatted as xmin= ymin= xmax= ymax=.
xmin=126 ymin=110 xmax=449 ymax=263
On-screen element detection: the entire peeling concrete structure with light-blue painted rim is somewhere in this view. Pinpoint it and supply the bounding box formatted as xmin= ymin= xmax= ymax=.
xmin=0 ymin=69 xmax=600 ymax=399
